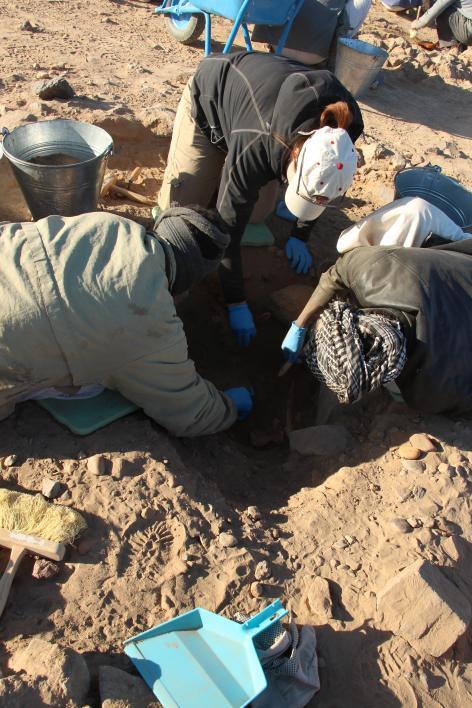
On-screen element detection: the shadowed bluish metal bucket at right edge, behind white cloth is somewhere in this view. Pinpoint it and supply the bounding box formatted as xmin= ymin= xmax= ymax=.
xmin=394 ymin=164 xmax=472 ymax=229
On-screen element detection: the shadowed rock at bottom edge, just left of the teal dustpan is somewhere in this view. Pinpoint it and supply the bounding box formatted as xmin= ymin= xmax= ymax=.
xmin=98 ymin=666 xmax=160 ymax=708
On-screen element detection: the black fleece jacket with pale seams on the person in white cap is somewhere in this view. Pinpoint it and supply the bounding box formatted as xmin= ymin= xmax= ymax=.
xmin=192 ymin=52 xmax=364 ymax=303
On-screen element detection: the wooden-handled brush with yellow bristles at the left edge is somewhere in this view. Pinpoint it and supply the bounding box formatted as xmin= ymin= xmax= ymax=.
xmin=0 ymin=489 xmax=87 ymax=615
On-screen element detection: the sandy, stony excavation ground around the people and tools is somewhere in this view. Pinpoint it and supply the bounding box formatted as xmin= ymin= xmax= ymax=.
xmin=0 ymin=0 xmax=472 ymax=708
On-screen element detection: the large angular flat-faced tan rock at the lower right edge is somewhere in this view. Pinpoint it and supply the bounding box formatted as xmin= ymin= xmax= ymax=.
xmin=377 ymin=559 xmax=472 ymax=656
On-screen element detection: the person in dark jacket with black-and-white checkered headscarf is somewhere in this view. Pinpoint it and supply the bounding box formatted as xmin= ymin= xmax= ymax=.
xmin=282 ymin=234 xmax=472 ymax=413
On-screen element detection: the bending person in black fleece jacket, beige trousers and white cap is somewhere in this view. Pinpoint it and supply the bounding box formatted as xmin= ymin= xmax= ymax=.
xmin=158 ymin=52 xmax=363 ymax=346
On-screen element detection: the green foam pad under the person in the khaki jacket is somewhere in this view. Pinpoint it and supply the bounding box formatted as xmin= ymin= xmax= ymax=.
xmin=36 ymin=389 xmax=138 ymax=435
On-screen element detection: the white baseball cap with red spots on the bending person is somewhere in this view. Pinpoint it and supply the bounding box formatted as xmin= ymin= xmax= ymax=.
xmin=285 ymin=126 xmax=357 ymax=221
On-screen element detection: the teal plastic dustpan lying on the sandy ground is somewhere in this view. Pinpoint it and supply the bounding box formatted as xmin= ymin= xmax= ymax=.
xmin=125 ymin=600 xmax=287 ymax=708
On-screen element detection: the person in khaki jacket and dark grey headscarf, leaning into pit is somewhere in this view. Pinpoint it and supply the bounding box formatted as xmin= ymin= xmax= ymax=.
xmin=0 ymin=208 xmax=252 ymax=437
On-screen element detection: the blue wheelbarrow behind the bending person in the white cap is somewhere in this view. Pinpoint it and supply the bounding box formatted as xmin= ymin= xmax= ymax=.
xmin=154 ymin=0 xmax=304 ymax=56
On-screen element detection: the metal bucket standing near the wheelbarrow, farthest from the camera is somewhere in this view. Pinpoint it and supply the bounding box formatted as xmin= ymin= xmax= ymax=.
xmin=334 ymin=37 xmax=388 ymax=98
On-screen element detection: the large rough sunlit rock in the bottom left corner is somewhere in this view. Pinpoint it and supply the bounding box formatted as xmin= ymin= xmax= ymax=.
xmin=9 ymin=637 xmax=90 ymax=706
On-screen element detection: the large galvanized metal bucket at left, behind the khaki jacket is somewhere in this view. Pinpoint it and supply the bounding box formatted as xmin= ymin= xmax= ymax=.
xmin=0 ymin=120 xmax=113 ymax=219
